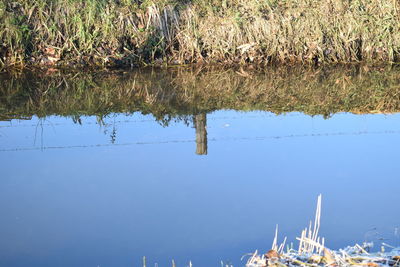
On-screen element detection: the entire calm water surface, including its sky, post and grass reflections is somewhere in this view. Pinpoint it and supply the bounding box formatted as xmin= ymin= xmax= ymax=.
xmin=0 ymin=66 xmax=400 ymax=267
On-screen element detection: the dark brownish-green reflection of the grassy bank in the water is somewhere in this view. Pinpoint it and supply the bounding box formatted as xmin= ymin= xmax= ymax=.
xmin=0 ymin=66 xmax=400 ymax=123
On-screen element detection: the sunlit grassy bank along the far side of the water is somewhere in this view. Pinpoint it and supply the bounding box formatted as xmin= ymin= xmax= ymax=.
xmin=0 ymin=0 xmax=400 ymax=67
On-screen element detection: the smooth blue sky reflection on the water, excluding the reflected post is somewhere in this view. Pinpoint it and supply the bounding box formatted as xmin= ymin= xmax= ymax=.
xmin=0 ymin=111 xmax=400 ymax=267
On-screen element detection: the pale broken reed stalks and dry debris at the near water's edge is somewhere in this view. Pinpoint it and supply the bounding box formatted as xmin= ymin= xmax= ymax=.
xmin=246 ymin=195 xmax=400 ymax=267
